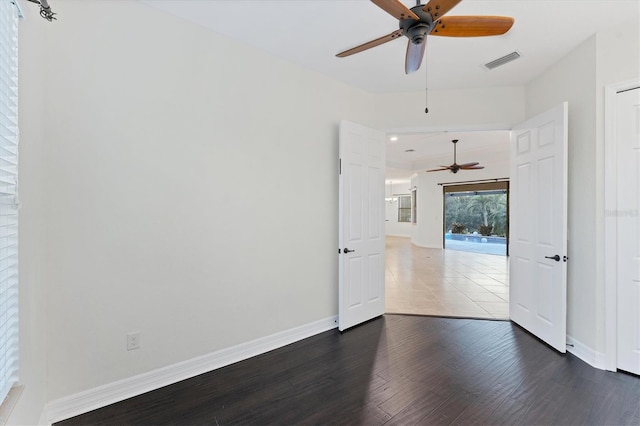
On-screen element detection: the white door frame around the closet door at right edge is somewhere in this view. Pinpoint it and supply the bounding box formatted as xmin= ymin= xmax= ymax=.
xmin=601 ymin=79 xmax=640 ymax=371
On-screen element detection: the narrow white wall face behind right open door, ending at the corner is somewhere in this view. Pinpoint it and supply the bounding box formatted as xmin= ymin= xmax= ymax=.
xmin=527 ymin=38 xmax=597 ymax=348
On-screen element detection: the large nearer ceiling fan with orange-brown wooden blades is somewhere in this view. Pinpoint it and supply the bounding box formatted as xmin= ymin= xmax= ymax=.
xmin=336 ymin=0 xmax=514 ymax=74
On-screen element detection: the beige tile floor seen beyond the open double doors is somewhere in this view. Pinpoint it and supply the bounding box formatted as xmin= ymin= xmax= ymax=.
xmin=385 ymin=233 xmax=509 ymax=319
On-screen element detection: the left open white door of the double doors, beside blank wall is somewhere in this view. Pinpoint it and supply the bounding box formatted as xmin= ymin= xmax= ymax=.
xmin=338 ymin=121 xmax=385 ymax=331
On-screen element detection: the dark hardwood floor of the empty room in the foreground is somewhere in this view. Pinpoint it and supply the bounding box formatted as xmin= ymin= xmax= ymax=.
xmin=56 ymin=315 xmax=640 ymax=426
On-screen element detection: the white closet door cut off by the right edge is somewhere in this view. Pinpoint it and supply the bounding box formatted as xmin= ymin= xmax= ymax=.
xmin=615 ymin=89 xmax=640 ymax=374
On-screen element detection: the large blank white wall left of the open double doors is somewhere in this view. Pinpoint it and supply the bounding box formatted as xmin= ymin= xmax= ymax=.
xmin=16 ymin=0 xmax=373 ymax=412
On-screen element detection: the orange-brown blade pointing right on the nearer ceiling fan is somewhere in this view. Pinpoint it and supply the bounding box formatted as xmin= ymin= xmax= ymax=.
xmin=430 ymin=16 xmax=514 ymax=37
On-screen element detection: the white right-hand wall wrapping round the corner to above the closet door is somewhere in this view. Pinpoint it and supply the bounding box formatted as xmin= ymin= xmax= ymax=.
xmin=527 ymin=19 xmax=640 ymax=355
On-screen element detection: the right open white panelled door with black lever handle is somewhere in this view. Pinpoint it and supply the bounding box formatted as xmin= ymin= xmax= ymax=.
xmin=509 ymin=102 xmax=567 ymax=353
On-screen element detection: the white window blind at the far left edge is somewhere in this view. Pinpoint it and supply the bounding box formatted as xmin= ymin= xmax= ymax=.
xmin=0 ymin=0 xmax=18 ymax=402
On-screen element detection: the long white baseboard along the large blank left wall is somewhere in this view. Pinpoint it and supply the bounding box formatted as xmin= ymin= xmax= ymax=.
xmin=44 ymin=317 xmax=338 ymax=425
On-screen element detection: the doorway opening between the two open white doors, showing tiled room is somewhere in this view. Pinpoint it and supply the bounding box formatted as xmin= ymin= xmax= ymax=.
xmin=385 ymin=130 xmax=509 ymax=319
